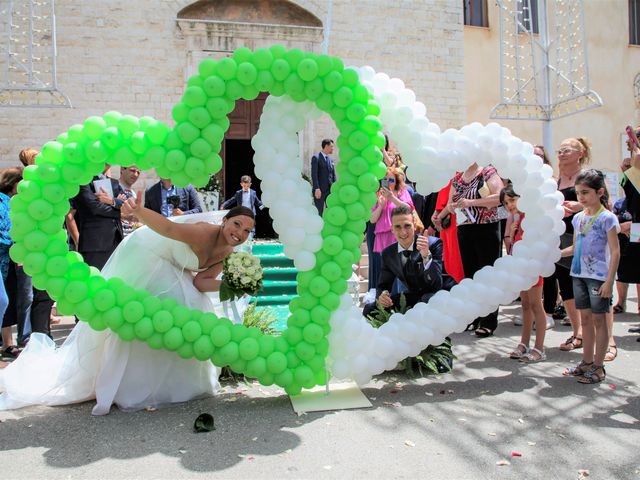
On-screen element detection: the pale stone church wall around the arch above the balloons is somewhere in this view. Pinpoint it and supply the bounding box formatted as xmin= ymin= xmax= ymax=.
xmin=0 ymin=0 xmax=466 ymax=187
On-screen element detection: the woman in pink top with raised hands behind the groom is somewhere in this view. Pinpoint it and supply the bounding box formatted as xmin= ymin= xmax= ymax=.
xmin=371 ymin=168 xmax=414 ymax=253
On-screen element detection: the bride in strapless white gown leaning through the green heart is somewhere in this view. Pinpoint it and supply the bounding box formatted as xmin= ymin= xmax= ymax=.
xmin=0 ymin=192 xmax=254 ymax=415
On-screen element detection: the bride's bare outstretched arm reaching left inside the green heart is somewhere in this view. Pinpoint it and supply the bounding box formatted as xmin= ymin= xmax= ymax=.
xmin=121 ymin=191 xmax=211 ymax=245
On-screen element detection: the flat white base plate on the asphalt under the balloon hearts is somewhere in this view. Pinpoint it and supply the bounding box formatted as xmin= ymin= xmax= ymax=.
xmin=289 ymin=382 xmax=372 ymax=415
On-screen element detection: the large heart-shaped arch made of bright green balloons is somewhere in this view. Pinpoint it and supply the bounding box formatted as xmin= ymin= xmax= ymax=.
xmin=10 ymin=45 xmax=386 ymax=395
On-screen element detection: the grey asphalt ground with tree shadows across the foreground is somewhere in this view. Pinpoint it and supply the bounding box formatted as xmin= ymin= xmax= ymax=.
xmin=0 ymin=298 xmax=640 ymax=480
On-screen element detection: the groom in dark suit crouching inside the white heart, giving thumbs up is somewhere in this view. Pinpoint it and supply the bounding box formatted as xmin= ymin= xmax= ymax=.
xmin=362 ymin=206 xmax=455 ymax=316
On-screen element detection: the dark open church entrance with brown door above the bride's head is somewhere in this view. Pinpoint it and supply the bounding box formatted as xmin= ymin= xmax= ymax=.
xmin=222 ymin=93 xmax=276 ymax=238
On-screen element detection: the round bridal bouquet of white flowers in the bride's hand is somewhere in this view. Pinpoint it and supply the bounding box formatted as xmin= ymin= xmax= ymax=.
xmin=220 ymin=252 xmax=262 ymax=302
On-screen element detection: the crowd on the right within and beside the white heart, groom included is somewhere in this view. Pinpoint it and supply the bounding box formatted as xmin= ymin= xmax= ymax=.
xmin=363 ymin=128 xmax=640 ymax=383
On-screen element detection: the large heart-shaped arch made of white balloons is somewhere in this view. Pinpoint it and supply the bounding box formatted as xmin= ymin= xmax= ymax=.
xmin=252 ymin=67 xmax=564 ymax=383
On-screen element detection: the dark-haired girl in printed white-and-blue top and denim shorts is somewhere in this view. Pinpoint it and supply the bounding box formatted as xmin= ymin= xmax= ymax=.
xmin=562 ymin=169 xmax=620 ymax=383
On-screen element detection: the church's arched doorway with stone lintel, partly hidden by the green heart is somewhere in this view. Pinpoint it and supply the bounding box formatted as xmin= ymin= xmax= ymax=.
xmin=177 ymin=0 xmax=323 ymax=238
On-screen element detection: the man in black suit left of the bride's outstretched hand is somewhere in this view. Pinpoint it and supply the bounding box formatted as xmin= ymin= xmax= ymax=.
xmin=72 ymin=165 xmax=125 ymax=269
